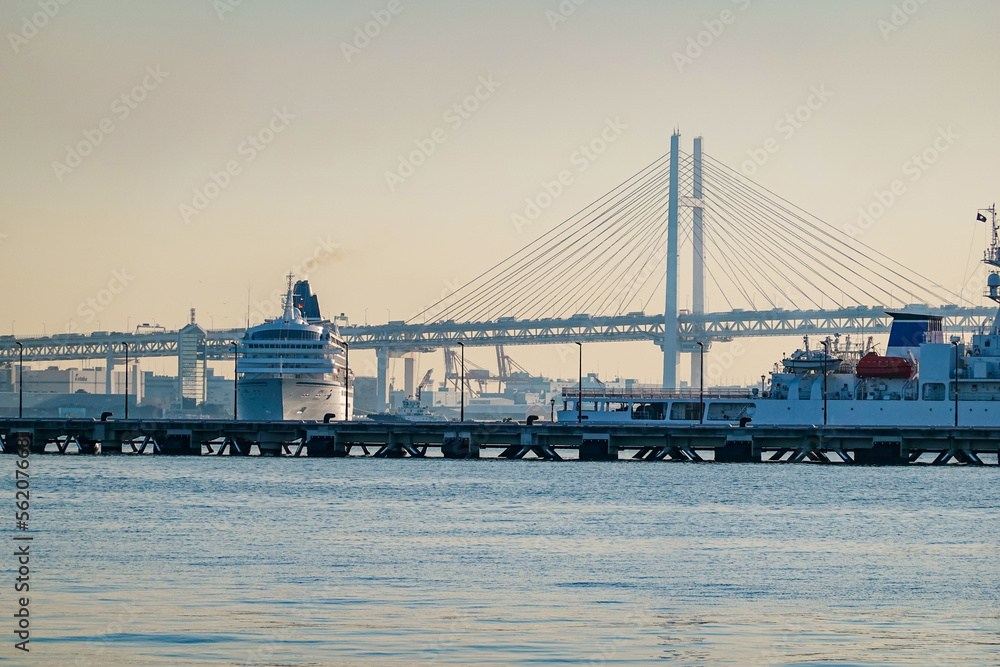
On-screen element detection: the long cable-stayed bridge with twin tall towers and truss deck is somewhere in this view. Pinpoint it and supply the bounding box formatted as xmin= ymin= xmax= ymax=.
xmin=0 ymin=134 xmax=996 ymax=406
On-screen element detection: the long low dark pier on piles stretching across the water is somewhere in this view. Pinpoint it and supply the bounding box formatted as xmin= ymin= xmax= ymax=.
xmin=0 ymin=419 xmax=1000 ymax=466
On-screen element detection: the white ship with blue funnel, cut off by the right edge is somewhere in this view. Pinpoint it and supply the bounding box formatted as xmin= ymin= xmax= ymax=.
xmin=559 ymin=206 xmax=1000 ymax=426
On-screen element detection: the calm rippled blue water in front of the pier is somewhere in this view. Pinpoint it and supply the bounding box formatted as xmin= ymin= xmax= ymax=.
xmin=0 ymin=455 xmax=1000 ymax=665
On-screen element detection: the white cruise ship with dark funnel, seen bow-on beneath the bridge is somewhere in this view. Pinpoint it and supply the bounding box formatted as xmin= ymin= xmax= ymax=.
xmin=236 ymin=275 xmax=354 ymax=421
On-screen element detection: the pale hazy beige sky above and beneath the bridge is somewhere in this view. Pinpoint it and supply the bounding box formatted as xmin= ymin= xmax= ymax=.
xmin=0 ymin=0 xmax=1000 ymax=383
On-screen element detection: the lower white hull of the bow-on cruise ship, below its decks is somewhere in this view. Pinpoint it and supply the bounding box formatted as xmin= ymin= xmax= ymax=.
xmin=237 ymin=377 xmax=354 ymax=421
